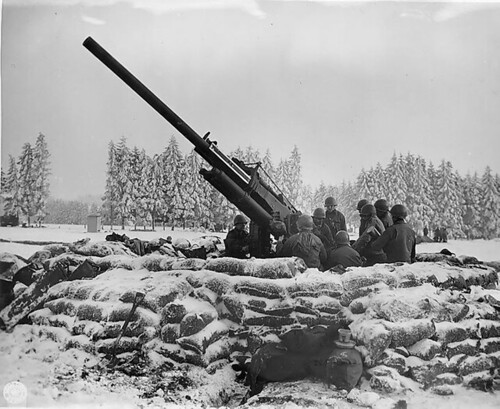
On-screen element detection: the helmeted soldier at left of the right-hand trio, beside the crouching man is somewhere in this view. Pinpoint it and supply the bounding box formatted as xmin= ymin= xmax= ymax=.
xmin=352 ymin=204 xmax=387 ymax=266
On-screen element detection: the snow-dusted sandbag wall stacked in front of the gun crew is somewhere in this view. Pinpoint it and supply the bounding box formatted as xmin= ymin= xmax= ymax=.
xmin=0 ymin=242 xmax=500 ymax=391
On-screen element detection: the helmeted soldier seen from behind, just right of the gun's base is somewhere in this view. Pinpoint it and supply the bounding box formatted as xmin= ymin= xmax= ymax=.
xmin=277 ymin=214 xmax=327 ymax=270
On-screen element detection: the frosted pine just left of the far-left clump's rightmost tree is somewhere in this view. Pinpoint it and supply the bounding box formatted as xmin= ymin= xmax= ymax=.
xmin=18 ymin=142 xmax=37 ymax=226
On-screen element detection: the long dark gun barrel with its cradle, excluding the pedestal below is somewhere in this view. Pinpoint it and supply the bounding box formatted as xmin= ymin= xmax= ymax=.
xmin=83 ymin=37 xmax=297 ymax=255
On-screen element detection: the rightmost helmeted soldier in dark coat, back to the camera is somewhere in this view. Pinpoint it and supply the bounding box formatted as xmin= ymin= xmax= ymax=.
xmin=372 ymin=204 xmax=417 ymax=263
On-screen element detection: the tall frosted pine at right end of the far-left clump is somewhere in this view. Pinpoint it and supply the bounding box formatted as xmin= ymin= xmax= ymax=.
xmin=33 ymin=132 xmax=50 ymax=223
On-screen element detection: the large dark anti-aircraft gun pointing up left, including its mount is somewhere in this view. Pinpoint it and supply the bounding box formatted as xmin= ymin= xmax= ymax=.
xmin=83 ymin=37 xmax=300 ymax=257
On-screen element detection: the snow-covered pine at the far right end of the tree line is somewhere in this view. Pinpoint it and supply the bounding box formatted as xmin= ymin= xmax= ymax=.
xmin=480 ymin=166 xmax=500 ymax=239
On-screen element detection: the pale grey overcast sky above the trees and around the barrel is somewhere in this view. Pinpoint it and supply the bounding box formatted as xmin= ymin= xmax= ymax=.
xmin=1 ymin=0 xmax=500 ymax=199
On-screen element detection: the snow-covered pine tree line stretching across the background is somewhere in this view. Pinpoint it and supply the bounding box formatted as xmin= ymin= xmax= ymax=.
xmin=2 ymin=134 xmax=500 ymax=239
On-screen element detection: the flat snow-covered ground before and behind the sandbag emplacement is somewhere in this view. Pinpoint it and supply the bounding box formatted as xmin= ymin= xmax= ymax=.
xmin=0 ymin=225 xmax=500 ymax=409
